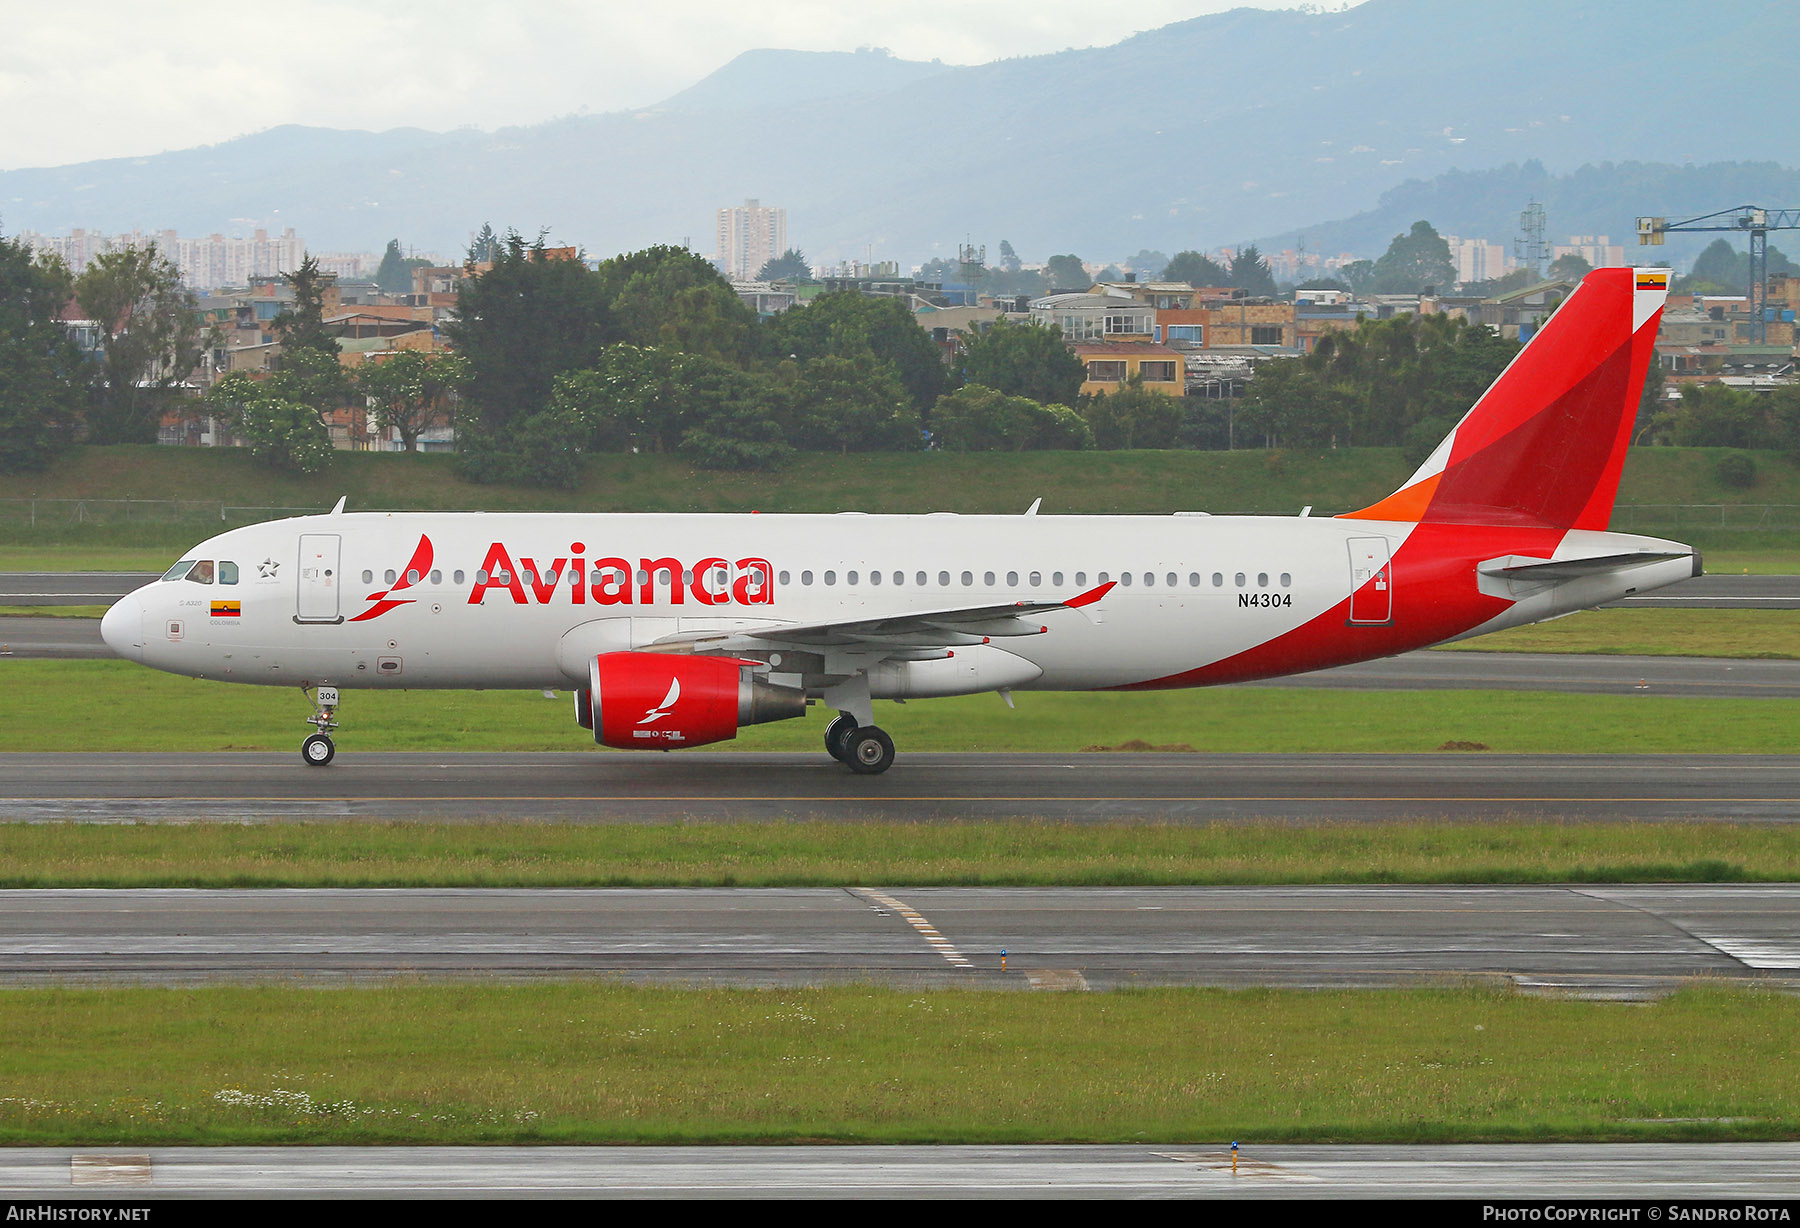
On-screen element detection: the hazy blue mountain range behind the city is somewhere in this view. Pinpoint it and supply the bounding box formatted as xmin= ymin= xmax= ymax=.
xmin=0 ymin=0 xmax=1800 ymax=263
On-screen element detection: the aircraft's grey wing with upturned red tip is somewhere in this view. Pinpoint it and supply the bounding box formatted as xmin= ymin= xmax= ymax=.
xmin=648 ymin=582 xmax=1116 ymax=659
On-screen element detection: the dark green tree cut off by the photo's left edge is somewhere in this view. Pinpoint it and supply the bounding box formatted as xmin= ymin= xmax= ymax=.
xmin=0 ymin=236 xmax=85 ymax=474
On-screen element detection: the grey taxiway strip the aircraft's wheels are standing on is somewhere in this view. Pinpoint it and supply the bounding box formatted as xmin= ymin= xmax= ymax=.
xmin=0 ymin=738 xmax=1800 ymax=823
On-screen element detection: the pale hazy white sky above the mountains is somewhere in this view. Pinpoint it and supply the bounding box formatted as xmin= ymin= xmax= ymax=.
xmin=0 ymin=0 xmax=1348 ymax=169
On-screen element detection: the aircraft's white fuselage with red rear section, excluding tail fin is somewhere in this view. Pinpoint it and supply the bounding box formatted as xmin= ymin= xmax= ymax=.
xmin=104 ymin=513 xmax=1694 ymax=699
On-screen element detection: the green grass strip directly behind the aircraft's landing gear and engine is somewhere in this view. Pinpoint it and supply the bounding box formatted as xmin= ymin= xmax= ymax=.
xmin=0 ymin=659 xmax=1800 ymax=754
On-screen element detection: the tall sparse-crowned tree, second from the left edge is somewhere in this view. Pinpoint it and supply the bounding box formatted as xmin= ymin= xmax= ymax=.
xmin=74 ymin=243 xmax=207 ymax=443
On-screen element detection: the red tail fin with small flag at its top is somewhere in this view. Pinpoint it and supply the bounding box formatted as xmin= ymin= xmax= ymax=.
xmin=1346 ymin=268 xmax=1669 ymax=529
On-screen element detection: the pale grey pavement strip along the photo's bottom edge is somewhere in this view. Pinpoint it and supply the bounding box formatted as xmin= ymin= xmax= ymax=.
xmin=0 ymin=1140 xmax=1800 ymax=1195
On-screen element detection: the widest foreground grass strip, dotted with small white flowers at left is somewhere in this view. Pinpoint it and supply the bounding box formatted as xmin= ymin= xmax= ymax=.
xmin=0 ymin=983 xmax=1800 ymax=1145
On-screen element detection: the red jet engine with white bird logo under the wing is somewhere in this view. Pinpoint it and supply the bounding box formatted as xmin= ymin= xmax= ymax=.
xmin=576 ymin=652 xmax=806 ymax=751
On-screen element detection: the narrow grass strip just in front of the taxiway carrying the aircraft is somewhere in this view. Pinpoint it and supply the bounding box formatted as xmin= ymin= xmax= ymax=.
xmin=0 ymin=814 xmax=1800 ymax=889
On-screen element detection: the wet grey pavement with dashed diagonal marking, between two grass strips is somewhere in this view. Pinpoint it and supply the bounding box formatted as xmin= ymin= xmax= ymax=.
xmin=0 ymin=884 xmax=1800 ymax=999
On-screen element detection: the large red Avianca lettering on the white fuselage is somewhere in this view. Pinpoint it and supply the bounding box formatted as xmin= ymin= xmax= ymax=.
xmin=468 ymin=542 xmax=776 ymax=605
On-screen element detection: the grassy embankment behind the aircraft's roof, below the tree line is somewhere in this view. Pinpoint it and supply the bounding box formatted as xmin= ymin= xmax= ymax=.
xmin=10 ymin=447 xmax=1800 ymax=573
